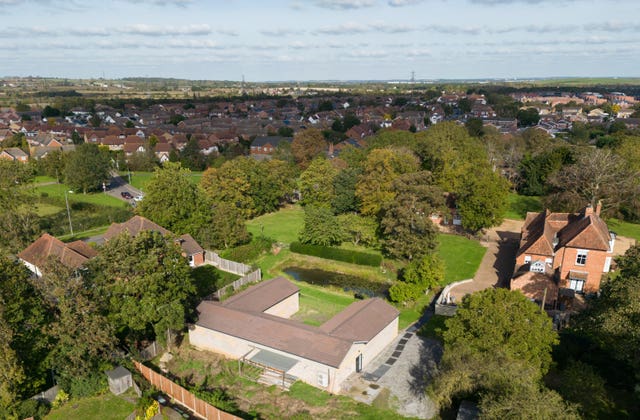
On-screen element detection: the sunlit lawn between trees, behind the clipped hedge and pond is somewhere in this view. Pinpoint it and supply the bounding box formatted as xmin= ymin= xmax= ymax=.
xmin=247 ymin=206 xmax=304 ymax=244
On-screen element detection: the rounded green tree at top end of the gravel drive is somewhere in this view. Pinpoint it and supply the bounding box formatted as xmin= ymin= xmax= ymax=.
xmin=456 ymin=170 xmax=509 ymax=232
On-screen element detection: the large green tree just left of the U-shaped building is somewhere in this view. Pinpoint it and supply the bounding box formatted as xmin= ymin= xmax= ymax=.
xmin=87 ymin=230 xmax=195 ymax=340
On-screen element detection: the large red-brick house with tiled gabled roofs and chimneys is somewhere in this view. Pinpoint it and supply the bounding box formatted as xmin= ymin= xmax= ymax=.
xmin=511 ymin=203 xmax=616 ymax=304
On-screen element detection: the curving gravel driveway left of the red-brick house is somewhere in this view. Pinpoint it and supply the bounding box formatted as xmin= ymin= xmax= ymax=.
xmin=451 ymin=220 xmax=524 ymax=302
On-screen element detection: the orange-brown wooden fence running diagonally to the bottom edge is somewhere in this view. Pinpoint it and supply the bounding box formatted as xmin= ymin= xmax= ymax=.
xmin=133 ymin=361 xmax=241 ymax=420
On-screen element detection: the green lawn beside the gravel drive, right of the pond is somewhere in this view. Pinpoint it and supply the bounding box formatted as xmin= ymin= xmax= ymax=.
xmin=438 ymin=234 xmax=487 ymax=286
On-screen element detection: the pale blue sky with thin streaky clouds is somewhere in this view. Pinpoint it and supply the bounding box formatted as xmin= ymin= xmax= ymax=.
xmin=0 ymin=0 xmax=640 ymax=81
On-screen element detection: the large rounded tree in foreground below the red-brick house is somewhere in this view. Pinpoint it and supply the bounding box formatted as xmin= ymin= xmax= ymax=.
xmin=428 ymin=289 xmax=560 ymax=418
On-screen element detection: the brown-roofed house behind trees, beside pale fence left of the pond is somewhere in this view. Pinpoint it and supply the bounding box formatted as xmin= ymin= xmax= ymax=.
xmin=103 ymin=216 xmax=204 ymax=267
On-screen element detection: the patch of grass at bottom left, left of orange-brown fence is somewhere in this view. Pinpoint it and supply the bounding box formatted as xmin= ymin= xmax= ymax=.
xmin=45 ymin=393 xmax=135 ymax=420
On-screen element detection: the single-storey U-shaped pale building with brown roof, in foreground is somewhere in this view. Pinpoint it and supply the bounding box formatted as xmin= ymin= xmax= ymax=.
xmin=189 ymin=277 xmax=399 ymax=393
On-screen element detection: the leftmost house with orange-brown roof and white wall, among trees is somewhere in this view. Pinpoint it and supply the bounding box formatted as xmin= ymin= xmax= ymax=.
xmin=18 ymin=233 xmax=98 ymax=277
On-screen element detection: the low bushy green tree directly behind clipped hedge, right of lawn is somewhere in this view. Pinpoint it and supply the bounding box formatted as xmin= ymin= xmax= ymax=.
xmin=299 ymin=206 xmax=344 ymax=246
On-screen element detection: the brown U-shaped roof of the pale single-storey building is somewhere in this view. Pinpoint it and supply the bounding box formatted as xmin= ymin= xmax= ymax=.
xmin=196 ymin=277 xmax=399 ymax=367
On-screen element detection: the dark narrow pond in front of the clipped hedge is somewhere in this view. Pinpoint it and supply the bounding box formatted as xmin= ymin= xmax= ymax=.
xmin=282 ymin=267 xmax=390 ymax=299
